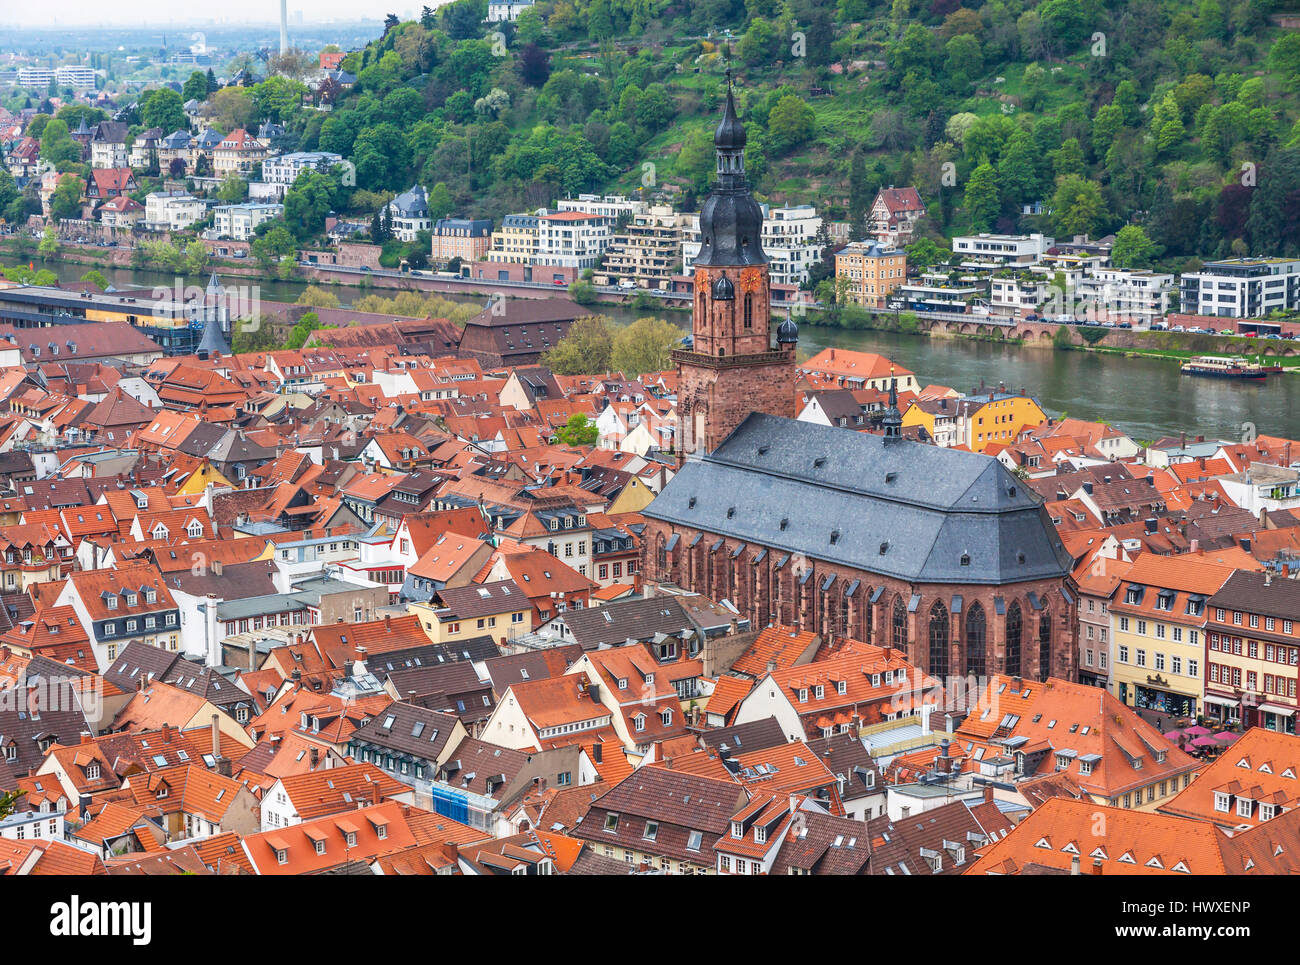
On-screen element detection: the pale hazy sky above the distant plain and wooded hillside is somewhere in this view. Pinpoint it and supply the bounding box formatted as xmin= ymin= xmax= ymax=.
xmin=0 ymin=0 xmax=431 ymax=29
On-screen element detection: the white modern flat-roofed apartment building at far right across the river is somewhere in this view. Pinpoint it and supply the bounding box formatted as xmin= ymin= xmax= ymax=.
xmin=1178 ymin=258 xmax=1300 ymax=319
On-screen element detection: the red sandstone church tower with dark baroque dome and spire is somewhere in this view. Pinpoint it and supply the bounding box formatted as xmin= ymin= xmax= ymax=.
xmin=672 ymin=70 xmax=798 ymax=466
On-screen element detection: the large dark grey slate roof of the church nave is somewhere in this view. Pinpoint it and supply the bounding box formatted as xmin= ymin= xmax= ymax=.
xmin=642 ymin=412 xmax=1071 ymax=584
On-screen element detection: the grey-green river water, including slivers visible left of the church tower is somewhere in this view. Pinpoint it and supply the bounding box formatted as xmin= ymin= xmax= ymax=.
xmin=40 ymin=264 xmax=1300 ymax=441
